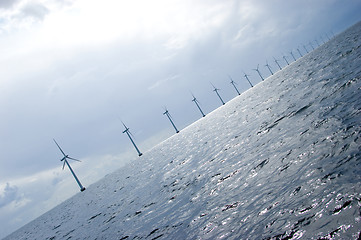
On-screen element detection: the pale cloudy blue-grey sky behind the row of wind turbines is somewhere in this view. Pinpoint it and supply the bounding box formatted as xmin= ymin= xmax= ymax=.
xmin=0 ymin=0 xmax=361 ymax=238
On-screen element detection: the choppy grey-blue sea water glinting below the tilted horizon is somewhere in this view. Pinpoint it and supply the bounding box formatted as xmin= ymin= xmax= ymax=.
xmin=3 ymin=24 xmax=361 ymax=239
